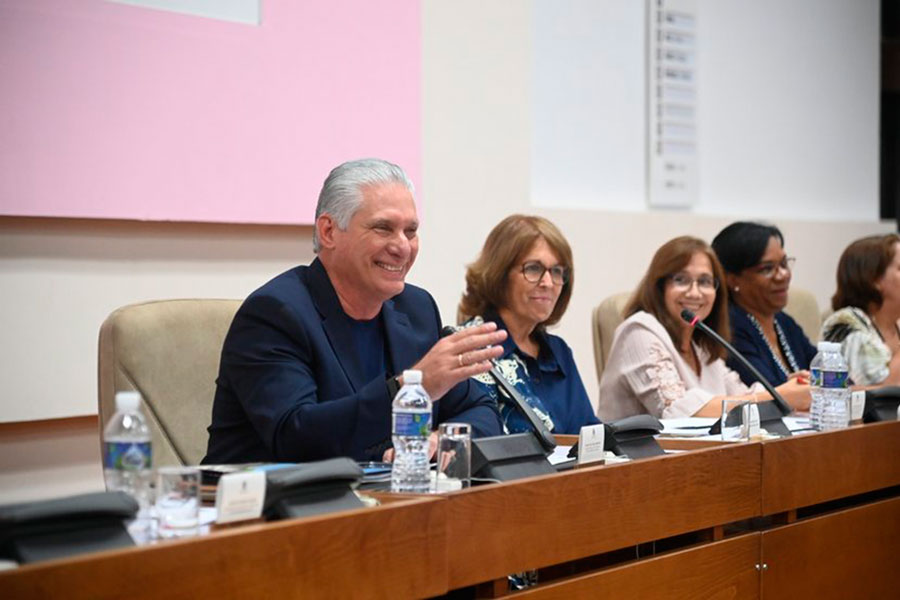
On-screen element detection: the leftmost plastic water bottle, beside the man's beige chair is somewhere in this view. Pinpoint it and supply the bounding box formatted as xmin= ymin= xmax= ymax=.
xmin=103 ymin=392 xmax=153 ymax=512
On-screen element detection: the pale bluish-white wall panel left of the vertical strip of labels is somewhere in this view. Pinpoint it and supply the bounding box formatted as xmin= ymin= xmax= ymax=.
xmin=530 ymin=0 xmax=647 ymax=212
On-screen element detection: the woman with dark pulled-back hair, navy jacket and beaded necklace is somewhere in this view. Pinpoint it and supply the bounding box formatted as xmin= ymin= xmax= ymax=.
xmin=712 ymin=221 xmax=816 ymax=385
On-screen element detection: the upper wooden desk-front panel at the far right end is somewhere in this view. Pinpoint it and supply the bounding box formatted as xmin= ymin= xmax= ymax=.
xmin=762 ymin=422 xmax=900 ymax=515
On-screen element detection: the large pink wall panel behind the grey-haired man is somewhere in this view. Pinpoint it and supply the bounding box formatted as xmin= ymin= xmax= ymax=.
xmin=0 ymin=0 xmax=421 ymax=223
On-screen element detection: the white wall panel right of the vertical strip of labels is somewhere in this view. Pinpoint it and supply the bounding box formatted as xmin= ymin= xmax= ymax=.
xmin=697 ymin=0 xmax=881 ymax=223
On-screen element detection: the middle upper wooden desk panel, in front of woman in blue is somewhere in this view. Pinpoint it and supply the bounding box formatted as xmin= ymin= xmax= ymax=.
xmin=447 ymin=444 xmax=760 ymax=589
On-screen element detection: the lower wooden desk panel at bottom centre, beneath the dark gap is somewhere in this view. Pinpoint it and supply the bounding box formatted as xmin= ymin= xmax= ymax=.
xmin=516 ymin=533 xmax=759 ymax=600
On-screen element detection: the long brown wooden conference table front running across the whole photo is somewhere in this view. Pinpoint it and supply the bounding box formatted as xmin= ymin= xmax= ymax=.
xmin=0 ymin=422 xmax=900 ymax=599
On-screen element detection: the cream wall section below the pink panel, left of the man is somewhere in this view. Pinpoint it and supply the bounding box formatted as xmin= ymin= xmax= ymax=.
xmin=0 ymin=219 xmax=313 ymax=421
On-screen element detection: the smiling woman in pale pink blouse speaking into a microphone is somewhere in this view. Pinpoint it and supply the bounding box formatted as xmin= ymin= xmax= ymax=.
xmin=597 ymin=236 xmax=809 ymax=421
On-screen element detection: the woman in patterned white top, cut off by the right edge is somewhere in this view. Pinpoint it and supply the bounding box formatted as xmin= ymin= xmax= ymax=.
xmin=822 ymin=233 xmax=900 ymax=385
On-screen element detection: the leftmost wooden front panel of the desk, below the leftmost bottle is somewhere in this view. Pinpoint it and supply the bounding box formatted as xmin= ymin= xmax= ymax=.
xmin=0 ymin=499 xmax=447 ymax=599
